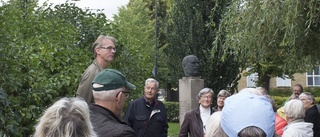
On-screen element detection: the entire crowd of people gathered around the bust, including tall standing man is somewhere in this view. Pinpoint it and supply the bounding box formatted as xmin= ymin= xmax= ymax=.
xmin=34 ymin=35 xmax=320 ymax=137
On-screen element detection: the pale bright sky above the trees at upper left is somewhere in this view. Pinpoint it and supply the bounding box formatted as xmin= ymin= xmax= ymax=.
xmin=0 ymin=0 xmax=129 ymax=19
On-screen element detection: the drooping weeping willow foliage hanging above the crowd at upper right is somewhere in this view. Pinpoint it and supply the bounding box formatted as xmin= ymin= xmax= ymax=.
xmin=214 ymin=0 xmax=320 ymax=88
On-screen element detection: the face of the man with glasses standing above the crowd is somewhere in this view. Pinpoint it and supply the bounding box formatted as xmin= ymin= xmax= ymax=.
xmin=96 ymin=39 xmax=116 ymax=63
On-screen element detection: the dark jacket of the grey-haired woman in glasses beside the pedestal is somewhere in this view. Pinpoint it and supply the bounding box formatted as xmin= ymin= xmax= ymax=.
xmin=179 ymin=107 xmax=214 ymax=137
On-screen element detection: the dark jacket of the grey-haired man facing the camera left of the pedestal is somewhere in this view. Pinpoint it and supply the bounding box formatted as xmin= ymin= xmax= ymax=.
xmin=125 ymin=97 xmax=168 ymax=137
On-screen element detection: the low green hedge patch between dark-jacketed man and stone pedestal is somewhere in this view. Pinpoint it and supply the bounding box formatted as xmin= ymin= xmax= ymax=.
xmin=163 ymin=102 xmax=179 ymax=123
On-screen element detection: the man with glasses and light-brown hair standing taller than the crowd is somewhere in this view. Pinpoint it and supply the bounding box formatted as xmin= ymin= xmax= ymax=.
xmin=77 ymin=35 xmax=116 ymax=103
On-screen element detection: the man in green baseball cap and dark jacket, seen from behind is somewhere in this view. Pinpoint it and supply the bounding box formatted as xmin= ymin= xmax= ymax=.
xmin=90 ymin=69 xmax=136 ymax=137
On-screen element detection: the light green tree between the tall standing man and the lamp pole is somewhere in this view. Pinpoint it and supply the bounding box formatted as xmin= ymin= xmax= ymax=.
xmin=111 ymin=0 xmax=155 ymax=99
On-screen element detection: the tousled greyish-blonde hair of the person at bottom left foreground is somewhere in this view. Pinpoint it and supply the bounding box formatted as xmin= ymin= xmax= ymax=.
xmin=34 ymin=98 xmax=97 ymax=137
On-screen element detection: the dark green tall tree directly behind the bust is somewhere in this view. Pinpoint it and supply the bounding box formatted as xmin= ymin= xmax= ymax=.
xmin=163 ymin=0 xmax=239 ymax=91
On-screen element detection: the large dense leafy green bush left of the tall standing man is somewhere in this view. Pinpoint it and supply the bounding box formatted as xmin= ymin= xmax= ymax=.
xmin=0 ymin=0 xmax=107 ymax=137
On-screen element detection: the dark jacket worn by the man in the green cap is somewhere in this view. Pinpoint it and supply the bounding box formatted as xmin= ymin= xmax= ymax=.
xmin=90 ymin=104 xmax=135 ymax=137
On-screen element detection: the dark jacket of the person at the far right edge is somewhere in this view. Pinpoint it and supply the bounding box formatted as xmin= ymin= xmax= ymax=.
xmin=304 ymin=105 xmax=320 ymax=137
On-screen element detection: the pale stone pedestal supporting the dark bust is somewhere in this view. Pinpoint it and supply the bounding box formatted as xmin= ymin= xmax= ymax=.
xmin=179 ymin=77 xmax=204 ymax=125
